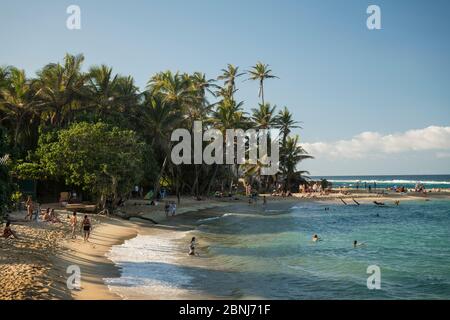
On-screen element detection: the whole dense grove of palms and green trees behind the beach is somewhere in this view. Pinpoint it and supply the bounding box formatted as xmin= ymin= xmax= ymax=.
xmin=0 ymin=55 xmax=309 ymax=208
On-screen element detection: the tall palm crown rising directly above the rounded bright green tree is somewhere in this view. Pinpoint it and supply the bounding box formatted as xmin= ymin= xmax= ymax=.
xmin=34 ymin=54 xmax=85 ymax=126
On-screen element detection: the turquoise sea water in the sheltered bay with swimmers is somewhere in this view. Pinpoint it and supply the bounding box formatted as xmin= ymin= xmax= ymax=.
xmin=106 ymin=200 xmax=450 ymax=299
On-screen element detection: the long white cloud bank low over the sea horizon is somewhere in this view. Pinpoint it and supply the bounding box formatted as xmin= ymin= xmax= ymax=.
xmin=302 ymin=126 xmax=450 ymax=159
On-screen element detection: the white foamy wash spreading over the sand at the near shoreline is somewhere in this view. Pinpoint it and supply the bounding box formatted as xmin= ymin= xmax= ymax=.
xmin=104 ymin=232 xmax=191 ymax=299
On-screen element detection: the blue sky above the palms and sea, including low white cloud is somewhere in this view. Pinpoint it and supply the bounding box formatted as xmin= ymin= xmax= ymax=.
xmin=0 ymin=0 xmax=450 ymax=175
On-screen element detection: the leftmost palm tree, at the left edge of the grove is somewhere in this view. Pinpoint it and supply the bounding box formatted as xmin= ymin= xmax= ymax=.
xmin=0 ymin=68 xmax=37 ymax=147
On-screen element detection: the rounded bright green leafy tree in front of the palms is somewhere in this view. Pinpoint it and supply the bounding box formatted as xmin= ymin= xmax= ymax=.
xmin=36 ymin=122 xmax=149 ymax=205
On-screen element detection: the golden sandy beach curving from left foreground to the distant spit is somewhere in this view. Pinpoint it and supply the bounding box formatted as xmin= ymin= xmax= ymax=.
xmin=0 ymin=192 xmax=449 ymax=300
